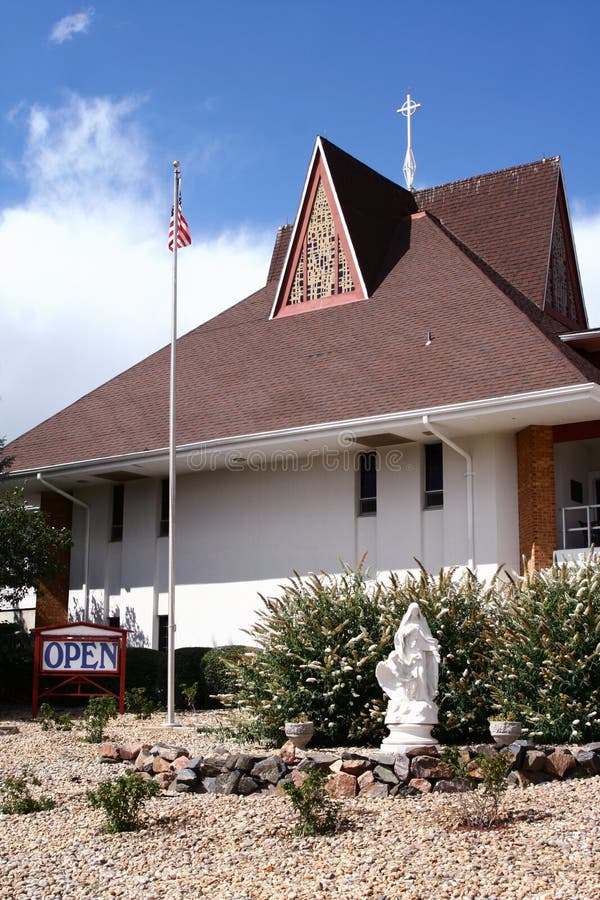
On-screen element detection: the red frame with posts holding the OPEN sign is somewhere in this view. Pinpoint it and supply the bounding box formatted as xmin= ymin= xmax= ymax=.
xmin=31 ymin=622 xmax=129 ymax=719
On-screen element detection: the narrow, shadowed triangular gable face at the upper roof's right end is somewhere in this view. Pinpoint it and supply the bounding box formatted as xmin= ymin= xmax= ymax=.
xmin=544 ymin=177 xmax=587 ymax=329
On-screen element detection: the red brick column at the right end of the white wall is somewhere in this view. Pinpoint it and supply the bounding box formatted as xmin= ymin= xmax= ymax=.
xmin=517 ymin=425 xmax=556 ymax=571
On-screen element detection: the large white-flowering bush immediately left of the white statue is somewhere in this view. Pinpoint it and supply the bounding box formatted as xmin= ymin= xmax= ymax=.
xmin=235 ymin=568 xmax=396 ymax=745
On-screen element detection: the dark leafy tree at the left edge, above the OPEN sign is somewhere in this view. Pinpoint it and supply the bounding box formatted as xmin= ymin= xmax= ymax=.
xmin=0 ymin=438 xmax=71 ymax=606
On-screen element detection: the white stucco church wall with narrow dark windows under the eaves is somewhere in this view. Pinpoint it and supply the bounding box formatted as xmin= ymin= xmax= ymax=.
xmin=70 ymin=435 xmax=518 ymax=646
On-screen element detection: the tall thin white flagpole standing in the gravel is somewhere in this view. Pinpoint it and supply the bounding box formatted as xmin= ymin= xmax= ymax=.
xmin=165 ymin=160 xmax=181 ymax=727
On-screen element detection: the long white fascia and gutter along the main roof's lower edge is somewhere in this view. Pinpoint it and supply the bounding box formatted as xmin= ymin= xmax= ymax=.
xmin=14 ymin=382 xmax=600 ymax=478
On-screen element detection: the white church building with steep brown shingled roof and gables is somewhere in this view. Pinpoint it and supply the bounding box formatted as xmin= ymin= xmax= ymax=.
xmin=6 ymin=137 xmax=600 ymax=648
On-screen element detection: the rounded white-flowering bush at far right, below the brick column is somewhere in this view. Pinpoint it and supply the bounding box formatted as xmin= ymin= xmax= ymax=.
xmin=488 ymin=554 xmax=600 ymax=742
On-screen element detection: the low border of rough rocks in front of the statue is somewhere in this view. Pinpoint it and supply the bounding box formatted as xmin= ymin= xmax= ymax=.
xmin=99 ymin=741 xmax=600 ymax=799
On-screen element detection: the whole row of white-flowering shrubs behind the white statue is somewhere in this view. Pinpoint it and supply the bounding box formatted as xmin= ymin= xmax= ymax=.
xmin=234 ymin=554 xmax=600 ymax=745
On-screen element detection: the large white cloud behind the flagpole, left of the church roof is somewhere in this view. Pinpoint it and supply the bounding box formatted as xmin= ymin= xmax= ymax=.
xmin=0 ymin=96 xmax=273 ymax=439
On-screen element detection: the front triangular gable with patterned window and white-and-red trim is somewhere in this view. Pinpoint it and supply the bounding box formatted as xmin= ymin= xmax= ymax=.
xmin=271 ymin=138 xmax=367 ymax=318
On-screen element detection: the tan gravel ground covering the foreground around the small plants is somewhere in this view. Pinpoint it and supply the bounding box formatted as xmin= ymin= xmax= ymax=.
xmin=0 ymin=712 xmax=600 ymax=900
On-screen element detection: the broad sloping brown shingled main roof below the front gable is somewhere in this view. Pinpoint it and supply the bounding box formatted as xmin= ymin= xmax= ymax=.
xmin=6 ymin=201 xmax=600 ymax=470
